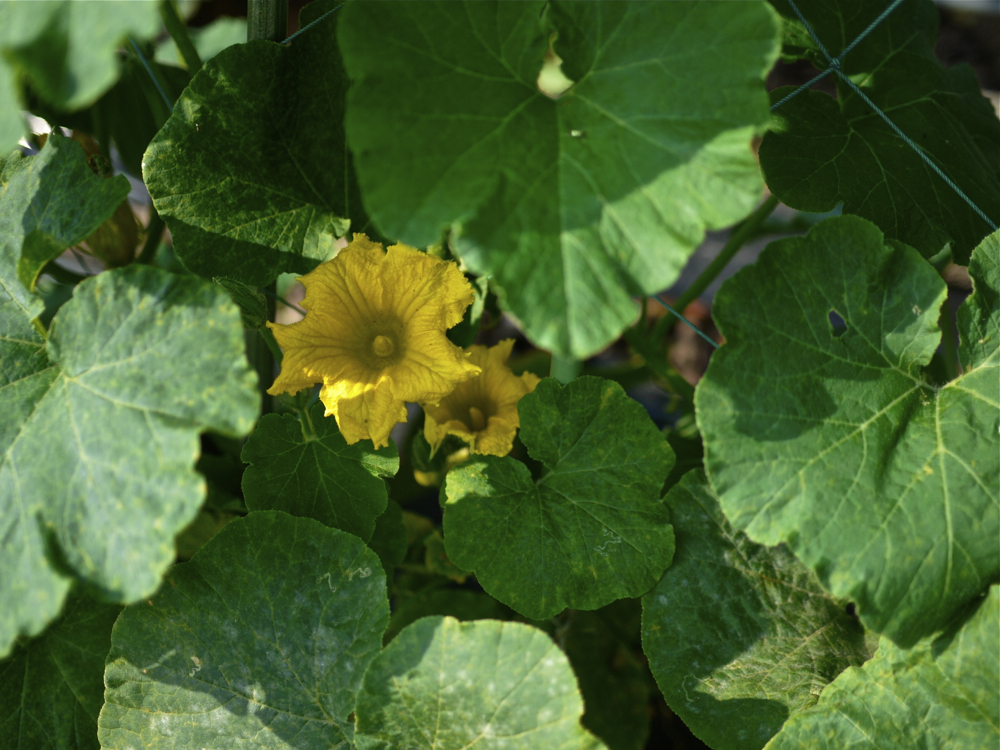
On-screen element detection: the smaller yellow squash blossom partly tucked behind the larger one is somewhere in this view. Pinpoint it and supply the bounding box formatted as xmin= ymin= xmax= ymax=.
xmin=424 ymin=339 xmax=539 ymax=456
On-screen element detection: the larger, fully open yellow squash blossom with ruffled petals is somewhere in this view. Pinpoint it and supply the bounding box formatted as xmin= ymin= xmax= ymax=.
xmin=267 ymin=234 xmax=479 ymax=448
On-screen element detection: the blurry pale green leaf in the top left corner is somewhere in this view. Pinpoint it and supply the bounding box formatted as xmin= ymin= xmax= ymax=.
xmin=0 ymin=0 xmax=160 ymax=152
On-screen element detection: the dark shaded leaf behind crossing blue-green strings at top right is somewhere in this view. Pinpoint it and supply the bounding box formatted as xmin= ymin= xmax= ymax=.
xmin=760 ymin=0 xmax=1000 ymax=265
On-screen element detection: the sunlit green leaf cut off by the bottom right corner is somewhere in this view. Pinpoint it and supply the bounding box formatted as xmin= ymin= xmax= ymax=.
xmin=767 ymin=586 xmax=1000 ymax=750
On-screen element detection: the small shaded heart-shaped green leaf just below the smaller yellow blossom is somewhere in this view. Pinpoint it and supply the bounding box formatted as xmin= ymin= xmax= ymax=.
xmin=444 ymin=377 xmax=674 ymax=620
